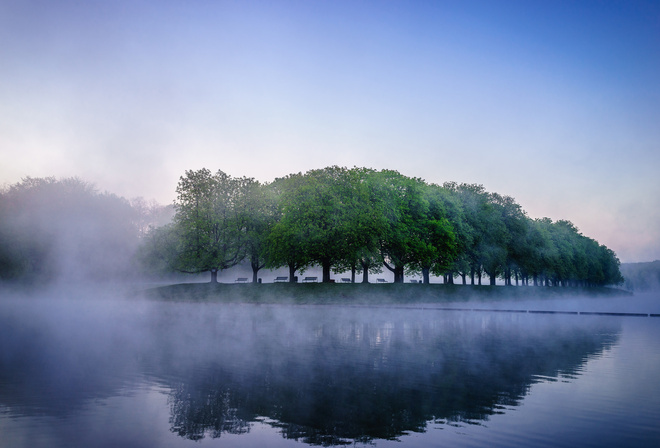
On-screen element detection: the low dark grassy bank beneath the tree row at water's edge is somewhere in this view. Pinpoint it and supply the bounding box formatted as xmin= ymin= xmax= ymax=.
xmin=144 ymin=283 xmax=630 ymax=304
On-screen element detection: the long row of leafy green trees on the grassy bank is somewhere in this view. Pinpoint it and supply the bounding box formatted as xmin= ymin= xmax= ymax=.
xmin=142 ymin=166 xmax=623 ymax=285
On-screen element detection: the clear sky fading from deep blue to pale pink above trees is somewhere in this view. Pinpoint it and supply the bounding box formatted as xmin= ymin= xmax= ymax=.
xmin=0 ymin=0 xmax=660 ymax=262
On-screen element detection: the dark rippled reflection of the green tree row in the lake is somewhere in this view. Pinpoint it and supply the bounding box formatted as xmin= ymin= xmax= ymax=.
xmin=161 ymin=307 xmax=618 ymax=445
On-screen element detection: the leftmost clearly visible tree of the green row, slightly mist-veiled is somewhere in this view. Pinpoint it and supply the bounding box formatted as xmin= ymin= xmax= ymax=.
xmin=174 ymin=168 xmax=254 ymax=283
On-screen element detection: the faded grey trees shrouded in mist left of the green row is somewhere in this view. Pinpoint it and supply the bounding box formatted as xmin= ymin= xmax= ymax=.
xmin=0 ymin=177 xmax=173 ymax=284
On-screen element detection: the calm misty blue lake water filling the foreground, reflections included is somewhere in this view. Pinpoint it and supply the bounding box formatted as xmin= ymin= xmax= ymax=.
xmin=0 ymin=296 xmax=660 ymax=448
